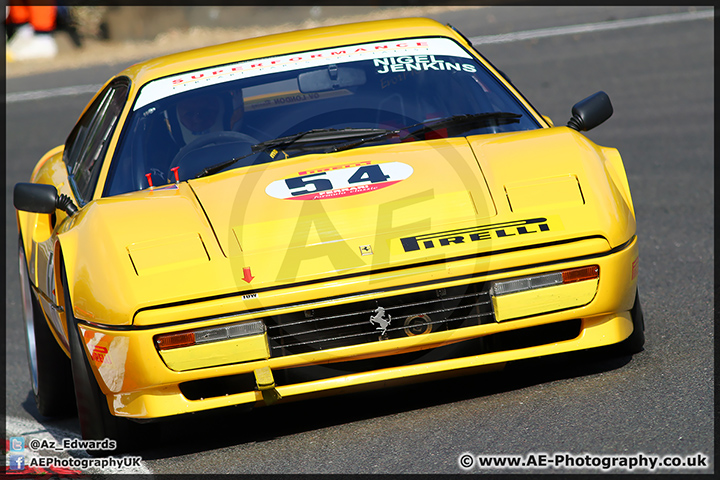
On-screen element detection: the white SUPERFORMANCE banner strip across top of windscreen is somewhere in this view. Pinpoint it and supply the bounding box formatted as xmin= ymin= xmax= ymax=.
xmin=134 ymin=38 xmax=472 ymax=110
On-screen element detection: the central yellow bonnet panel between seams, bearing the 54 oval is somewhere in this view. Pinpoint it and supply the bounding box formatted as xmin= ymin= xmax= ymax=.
xmin=190 ymin=138 xmax=497 ymax=282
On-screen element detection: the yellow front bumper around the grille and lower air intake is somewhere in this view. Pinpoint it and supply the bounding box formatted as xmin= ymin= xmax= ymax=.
xmin=80 ymin=239 xmax=638 ymax=419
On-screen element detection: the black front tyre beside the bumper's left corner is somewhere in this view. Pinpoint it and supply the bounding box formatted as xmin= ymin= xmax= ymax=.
xmin=62 ymin=262 xmax=140 ymax=456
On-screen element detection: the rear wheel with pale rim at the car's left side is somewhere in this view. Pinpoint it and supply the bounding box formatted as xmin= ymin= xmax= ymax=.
xmin=18 ymin=239 xmax=75 ymax=417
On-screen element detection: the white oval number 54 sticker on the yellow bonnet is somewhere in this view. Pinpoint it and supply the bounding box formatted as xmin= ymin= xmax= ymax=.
xmin=265 ymin=162 xmax=413 ymax=200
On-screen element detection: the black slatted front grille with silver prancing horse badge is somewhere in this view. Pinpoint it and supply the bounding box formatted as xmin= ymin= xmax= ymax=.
xmin=265 ymin=284 xmax=495 ymax=357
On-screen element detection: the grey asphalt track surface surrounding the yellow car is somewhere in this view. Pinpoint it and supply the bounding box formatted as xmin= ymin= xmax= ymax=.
xmin=6 ymin=7 xmax=715 ymax=474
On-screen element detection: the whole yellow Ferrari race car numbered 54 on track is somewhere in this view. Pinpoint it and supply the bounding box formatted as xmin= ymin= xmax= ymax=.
xmin=14 ymin=19 xmax=644 ymax=450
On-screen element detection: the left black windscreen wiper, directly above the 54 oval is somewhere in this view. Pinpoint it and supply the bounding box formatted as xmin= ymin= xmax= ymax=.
xmin=195 ymin=128 xmax=392 ymax=178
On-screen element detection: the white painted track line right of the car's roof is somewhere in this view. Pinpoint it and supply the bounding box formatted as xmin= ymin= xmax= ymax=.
xmin=468 ymin=10 xmax=715 ymax=45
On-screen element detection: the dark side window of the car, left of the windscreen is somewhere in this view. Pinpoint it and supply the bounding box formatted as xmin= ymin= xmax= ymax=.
xmin=65 ymin=79 xmax=128 ymax=204
